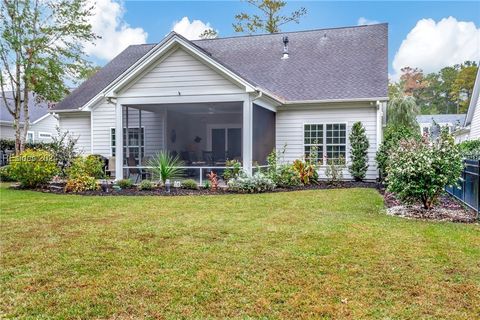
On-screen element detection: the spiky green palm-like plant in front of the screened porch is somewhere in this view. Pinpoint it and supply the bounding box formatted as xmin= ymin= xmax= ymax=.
xmin=148 ymin=150 xmax=184 ymax=184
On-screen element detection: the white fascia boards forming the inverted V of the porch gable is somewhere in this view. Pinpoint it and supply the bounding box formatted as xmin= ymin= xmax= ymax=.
xmin=102 ymin=35 xmax=256 ymax=97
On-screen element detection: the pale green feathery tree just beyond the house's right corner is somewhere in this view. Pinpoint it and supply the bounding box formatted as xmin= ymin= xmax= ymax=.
xmin=387 ymin=95 xmax=419 ymax=128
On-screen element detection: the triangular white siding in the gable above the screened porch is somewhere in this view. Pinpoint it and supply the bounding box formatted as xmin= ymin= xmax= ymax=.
xmin=121 ymin=49 xmax=244 ymax=97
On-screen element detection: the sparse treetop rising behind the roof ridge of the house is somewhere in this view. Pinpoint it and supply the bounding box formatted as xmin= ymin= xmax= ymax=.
xmin=233 ymin=0 xmax=307 ymax=34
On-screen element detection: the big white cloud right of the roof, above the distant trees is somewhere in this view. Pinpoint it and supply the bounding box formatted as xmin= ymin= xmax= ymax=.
xmin=392 ymin=17 xmax=480 ymax=79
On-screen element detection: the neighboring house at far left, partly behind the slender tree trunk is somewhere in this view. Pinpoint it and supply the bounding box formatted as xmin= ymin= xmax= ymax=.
xmin=0 ymin=92 xmax=58 ymax=142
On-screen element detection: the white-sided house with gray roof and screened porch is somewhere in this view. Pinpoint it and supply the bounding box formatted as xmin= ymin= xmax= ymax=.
xmin=53 ymin=24 xmax=388 ymax=179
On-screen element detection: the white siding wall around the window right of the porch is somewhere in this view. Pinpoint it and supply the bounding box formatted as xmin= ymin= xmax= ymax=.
xmin=276 ymin=103 xmax=381 ymax=179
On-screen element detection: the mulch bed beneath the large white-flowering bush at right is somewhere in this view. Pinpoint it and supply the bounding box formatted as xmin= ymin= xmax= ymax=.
xmin=380 ymin=189 xmax=478 ymax=223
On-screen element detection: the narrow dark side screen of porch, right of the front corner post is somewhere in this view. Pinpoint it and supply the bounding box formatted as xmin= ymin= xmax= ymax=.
xmin=252 ymin=104 xmax=275 ymax=165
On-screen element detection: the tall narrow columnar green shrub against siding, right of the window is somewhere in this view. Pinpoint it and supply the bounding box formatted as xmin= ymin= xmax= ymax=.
xmin=348 ymin=122 xmax=370 ymax=181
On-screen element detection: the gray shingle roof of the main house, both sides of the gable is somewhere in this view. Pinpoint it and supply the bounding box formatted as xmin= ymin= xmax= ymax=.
xmin=56 ymin=24 xmax=388 ymax=109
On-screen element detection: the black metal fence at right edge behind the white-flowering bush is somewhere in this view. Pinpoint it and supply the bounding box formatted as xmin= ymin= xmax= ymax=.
xmin=446 ymin=159 xmax=480 ymax=212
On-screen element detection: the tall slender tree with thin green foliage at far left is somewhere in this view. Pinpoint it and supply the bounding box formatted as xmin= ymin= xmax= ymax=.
xmin=0 ymin=0 xmax=97 ymax=154
